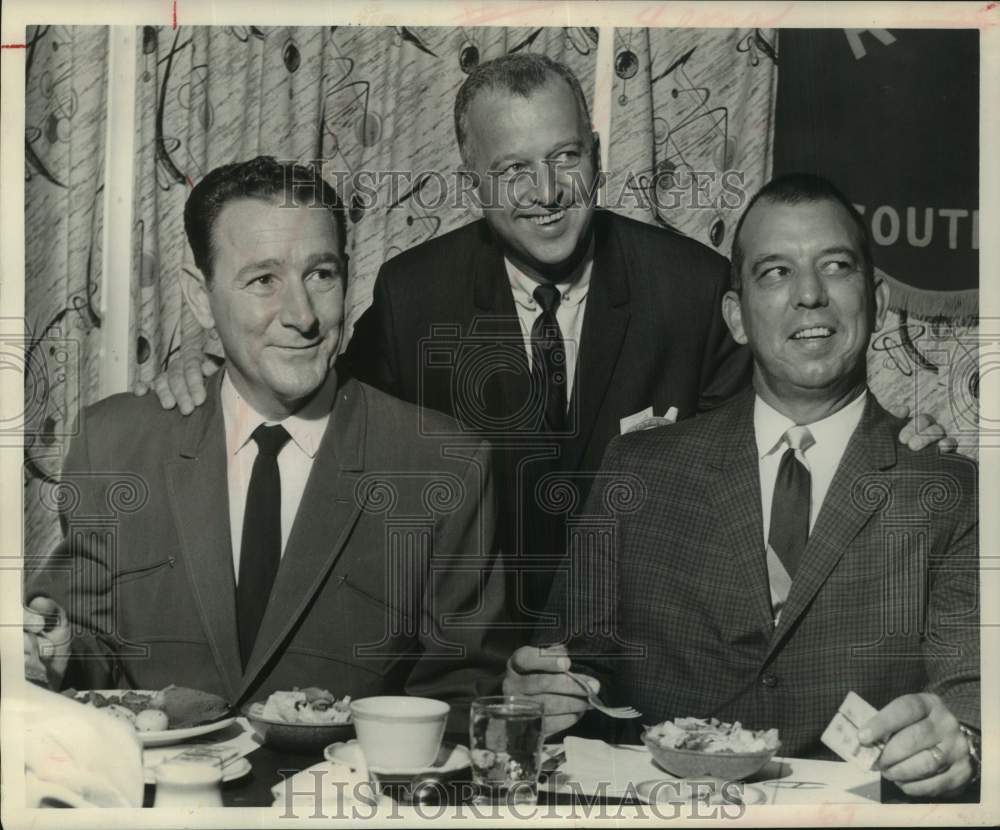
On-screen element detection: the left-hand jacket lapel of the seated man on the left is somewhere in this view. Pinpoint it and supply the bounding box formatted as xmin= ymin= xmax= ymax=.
xmin=165 ymin=372 xmax=242 ymax=703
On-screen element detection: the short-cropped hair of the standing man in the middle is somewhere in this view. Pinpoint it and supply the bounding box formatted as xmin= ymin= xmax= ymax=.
xmin=455 ymin=52 xmax=591 ymax=164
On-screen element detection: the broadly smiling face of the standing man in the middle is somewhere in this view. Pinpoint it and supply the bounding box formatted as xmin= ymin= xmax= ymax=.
xmin=467 ymin=76 xmax=597 ymax=281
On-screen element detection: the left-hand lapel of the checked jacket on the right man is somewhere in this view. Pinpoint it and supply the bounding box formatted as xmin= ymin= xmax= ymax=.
xmin=707 ymin=389 xmax=774 ymax=637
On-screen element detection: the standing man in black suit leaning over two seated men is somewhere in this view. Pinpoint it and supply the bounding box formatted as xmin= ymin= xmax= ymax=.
xmin=148 ymin=53 xmax=937 ymax=627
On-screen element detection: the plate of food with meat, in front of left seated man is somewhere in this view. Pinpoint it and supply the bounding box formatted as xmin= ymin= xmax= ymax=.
xmin=63 ymin=686 xmax=236 ymax=746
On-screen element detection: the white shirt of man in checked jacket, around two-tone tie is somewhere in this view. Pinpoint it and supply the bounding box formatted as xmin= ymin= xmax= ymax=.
xmin=753 ymin=392 xmax=865 ymax=625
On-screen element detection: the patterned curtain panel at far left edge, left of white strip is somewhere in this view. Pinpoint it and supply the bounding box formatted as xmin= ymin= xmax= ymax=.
xmin=24 ymin=26 xmax=108 ymax=555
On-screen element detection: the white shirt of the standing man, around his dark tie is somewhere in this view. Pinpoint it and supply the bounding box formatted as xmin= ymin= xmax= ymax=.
xmin=504 ymin=242 xmax=594 ymax=407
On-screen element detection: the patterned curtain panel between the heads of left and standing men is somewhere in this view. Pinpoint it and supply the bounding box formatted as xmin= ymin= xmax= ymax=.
xmin=133 ymin=26 xmax=596 ymax=380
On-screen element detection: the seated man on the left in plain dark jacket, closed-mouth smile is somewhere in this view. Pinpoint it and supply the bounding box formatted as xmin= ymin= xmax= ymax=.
xmin=26 ymin=158 xmax=504 ymax=721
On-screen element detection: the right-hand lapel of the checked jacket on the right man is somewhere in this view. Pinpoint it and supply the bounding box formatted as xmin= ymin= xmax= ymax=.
xmin=770 ymin=394 xmax=896 ymax=652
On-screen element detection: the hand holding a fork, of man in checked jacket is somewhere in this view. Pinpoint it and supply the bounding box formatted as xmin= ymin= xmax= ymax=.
xmin=503 ymin=646 xmax=601 ymax=735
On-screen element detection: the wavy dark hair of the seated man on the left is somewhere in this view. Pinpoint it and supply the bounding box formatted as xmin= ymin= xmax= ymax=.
xmin=184 ymin=156 xmax=347 ymax=281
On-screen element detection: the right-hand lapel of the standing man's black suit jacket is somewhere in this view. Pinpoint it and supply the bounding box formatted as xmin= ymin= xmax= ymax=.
xmin=565 ymin=211 xmax=630 ymax=469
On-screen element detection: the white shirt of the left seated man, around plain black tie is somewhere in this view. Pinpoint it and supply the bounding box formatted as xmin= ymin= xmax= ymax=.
xmin=222 ymin=373 xmax=337 ymax=580
